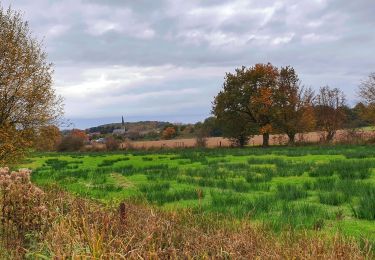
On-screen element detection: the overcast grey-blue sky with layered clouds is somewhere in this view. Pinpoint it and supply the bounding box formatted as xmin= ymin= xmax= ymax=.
xmin=0 ymin=0 xmax=375 ymax=128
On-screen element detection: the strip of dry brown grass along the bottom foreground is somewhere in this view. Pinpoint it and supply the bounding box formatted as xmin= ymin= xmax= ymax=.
xmin=0 ymin=168 xmax=373 ymax=259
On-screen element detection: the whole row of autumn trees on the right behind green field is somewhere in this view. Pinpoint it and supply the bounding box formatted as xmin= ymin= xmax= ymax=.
xmin=211 ymin=63 xmax=375 ymax=146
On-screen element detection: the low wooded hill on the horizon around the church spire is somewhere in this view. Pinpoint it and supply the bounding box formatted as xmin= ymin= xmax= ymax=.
xmin=86 ymin=121 xmax=171 ymax=134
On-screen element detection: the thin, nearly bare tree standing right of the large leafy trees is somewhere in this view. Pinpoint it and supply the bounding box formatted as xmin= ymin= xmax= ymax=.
xmin=315 ymin=86 xmax=346 ymax=142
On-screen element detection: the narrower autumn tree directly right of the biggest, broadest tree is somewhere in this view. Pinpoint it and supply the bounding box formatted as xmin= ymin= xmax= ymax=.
xmin=273 ymin=66 xmax=315 ymax=143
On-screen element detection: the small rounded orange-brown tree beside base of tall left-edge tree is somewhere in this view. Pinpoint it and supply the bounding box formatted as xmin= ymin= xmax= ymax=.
xmin=34 ymin=125 xmax=62 ymax=151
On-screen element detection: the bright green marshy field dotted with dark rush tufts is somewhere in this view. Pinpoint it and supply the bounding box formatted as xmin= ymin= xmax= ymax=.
xmin=22 ymin=146 xmax=375 ymax=243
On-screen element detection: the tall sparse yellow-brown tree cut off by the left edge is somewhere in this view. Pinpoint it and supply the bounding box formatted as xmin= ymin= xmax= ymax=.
xmin=0 ymin=7 xmax=62 ymax=164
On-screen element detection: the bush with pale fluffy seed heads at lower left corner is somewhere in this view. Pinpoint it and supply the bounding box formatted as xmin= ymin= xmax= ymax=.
xmin=0 ymin=168 xmax=51 ymax=246
